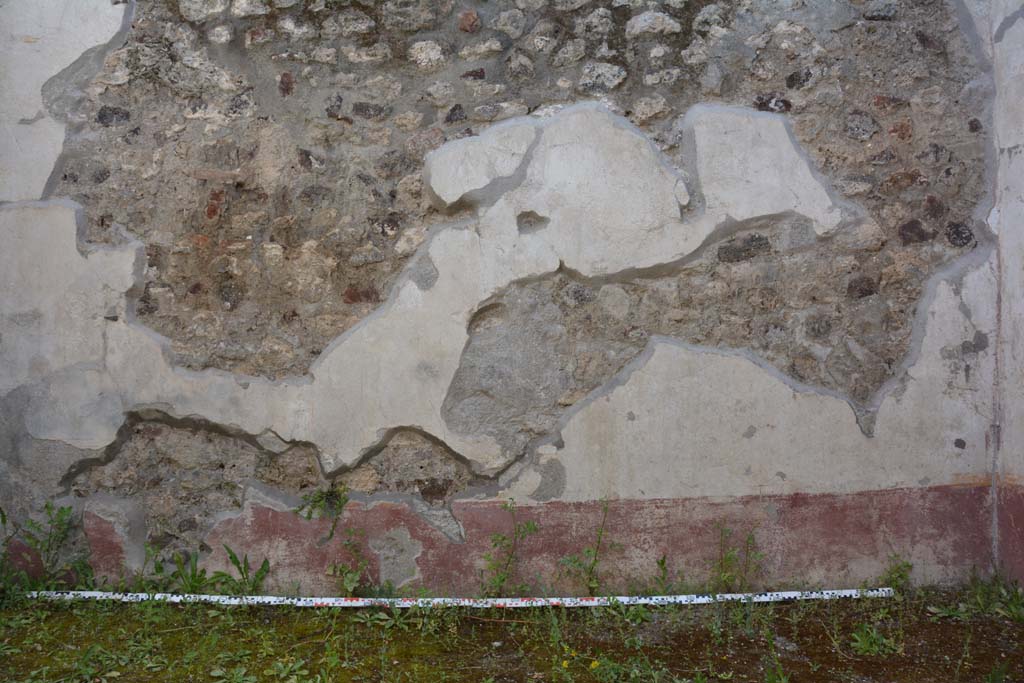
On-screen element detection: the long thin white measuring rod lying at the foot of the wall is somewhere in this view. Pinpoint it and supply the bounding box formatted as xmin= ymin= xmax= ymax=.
xmin=29 ymin=588 xmax=893 ymax=609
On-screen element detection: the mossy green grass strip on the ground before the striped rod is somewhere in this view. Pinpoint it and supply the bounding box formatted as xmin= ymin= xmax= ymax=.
xmin=0 ymin=581 xmax=1024 ymax=683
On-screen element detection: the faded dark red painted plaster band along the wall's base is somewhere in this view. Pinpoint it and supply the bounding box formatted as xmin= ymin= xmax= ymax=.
xmin=174 ymin=485 xmax=991 ymax=595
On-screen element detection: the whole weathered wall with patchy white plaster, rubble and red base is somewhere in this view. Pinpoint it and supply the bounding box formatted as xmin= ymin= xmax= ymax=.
xmin=0 ymin=0 xmax=1024 ymax=594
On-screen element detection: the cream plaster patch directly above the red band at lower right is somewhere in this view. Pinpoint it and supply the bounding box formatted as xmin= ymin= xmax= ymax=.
xmin=503 ymin=256 xmax=995 ymax=501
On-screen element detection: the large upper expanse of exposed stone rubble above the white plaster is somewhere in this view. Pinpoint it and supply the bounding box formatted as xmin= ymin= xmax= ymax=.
xmin=56 ymin=0 xmax=985 ymax=382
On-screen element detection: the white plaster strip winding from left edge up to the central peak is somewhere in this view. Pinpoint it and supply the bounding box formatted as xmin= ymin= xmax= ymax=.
xmin=3 ymin=104 xmax=864 ymax=483
